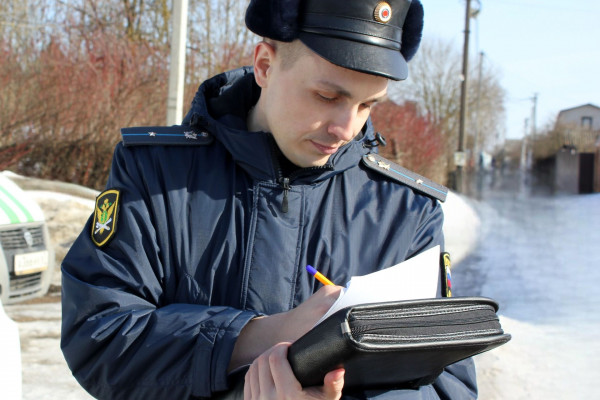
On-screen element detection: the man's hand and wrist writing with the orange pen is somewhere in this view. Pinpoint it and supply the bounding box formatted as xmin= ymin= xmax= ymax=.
xmin=229 ymin=285 xmax=342 ymax=371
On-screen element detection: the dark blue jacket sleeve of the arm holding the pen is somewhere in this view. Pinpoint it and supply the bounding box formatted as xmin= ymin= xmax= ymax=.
xmin=61 ymin=146 xmax=256 ymax=400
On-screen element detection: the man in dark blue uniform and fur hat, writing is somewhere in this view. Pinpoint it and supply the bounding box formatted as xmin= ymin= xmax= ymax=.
xmin=61 ymin=0 xmax=476 ymax=400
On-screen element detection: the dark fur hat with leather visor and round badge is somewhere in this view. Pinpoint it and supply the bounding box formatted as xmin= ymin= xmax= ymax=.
xmin=246 ymin=0 xmax=423 ymax=80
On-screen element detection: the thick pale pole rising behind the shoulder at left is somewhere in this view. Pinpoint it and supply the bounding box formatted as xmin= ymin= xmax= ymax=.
xmin=167 ymin=0 xmax=188 ymax=126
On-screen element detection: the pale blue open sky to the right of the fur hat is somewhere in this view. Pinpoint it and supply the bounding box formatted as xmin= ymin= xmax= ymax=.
xmin=421 ymin=0 xmax=600 ymax=139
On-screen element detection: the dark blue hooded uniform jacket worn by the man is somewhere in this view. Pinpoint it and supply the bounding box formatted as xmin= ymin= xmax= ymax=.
xmin=61 ymin=69 xmax=476 ymax=400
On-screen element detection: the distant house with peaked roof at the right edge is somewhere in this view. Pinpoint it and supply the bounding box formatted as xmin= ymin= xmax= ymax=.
xmin=554 ymin=104 xmax=600 ymax=152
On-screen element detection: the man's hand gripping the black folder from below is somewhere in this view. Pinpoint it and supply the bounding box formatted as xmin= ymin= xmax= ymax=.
xmin=244 ymin=343 xmax=345 ymax=400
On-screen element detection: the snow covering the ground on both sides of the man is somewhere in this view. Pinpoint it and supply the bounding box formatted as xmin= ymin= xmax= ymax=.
xmin=0 ymin=176 xmax=600 ymax=400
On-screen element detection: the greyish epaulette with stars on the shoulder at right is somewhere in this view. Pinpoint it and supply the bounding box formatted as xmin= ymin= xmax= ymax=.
xmin=363 ymin=153 xmax=448 ymax=202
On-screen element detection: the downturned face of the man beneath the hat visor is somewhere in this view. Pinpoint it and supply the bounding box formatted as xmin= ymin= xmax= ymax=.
xmin=261 ymin=43 xmax=388 ymax=167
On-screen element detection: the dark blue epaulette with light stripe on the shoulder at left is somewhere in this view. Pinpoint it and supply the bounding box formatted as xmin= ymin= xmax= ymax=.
xmin=121 ymin=125 xmax=214 ymax=146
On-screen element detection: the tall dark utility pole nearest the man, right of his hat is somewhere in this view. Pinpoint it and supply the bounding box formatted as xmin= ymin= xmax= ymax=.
xmin=454 ymin=0 xmax=471 ymax=192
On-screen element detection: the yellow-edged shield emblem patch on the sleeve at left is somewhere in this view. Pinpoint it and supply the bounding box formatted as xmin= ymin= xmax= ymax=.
xmin=91 ymin=189 xmax=120 ymax=247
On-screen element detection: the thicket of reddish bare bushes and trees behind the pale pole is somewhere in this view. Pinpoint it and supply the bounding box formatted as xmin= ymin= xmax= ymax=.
xmin=0 ymin=0 xmax=256 ymax=189
